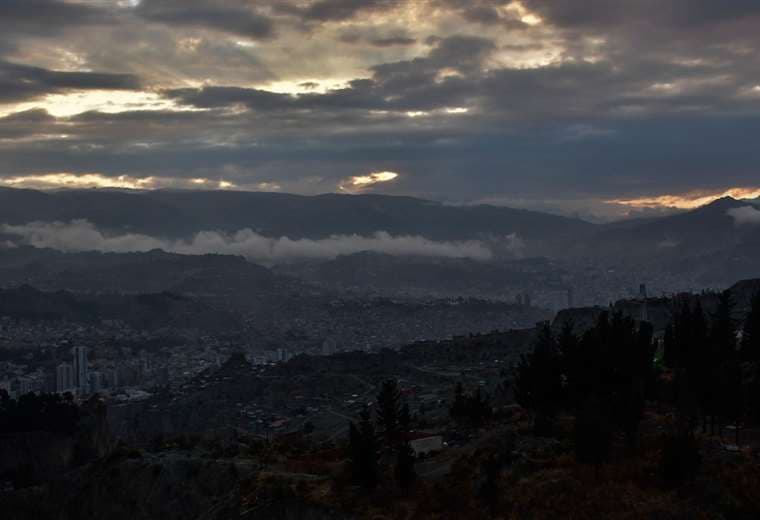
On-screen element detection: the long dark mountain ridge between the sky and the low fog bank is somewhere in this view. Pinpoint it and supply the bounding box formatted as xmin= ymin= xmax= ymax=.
xmin=0 ymin=189 xmax=593 ymax=246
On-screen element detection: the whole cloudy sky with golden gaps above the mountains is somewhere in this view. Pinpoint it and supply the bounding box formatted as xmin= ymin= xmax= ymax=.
xmin=0 ymin=0 xmax=760 ymax=219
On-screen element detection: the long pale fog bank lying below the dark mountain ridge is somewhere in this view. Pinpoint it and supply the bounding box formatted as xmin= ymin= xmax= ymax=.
xmin=0 ymin=220 xmax=524 ymax=264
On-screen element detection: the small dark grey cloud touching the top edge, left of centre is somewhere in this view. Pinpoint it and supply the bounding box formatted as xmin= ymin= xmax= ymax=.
xmin=136 ymin=0 xmax=275 ymax=39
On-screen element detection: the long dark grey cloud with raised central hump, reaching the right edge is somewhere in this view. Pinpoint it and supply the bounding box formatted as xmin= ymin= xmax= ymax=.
xmin=167 ymin=29 xmax=758 ymax=124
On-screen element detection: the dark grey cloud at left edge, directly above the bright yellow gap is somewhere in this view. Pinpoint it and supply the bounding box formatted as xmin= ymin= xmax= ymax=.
xmin=0 ymin=61 xmax=140 ymax=103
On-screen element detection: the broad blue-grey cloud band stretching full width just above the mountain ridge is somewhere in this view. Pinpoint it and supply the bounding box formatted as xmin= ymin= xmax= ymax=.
xmin=5 ymin=104 xmax=760 ymax=204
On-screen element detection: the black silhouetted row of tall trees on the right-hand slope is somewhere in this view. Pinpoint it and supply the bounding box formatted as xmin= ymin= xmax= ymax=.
xmin=514 ymin=291 xmax=760 ymax=478
